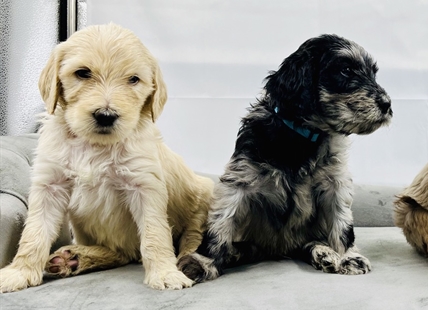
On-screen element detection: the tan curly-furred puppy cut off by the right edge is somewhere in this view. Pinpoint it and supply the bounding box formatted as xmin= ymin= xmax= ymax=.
xmin=394 ymin=164 xmax=428 ymax=257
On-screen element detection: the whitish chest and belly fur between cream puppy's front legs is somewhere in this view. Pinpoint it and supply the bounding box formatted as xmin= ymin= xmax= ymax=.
xmin=62 ymin=139 xmax=138 ymax=248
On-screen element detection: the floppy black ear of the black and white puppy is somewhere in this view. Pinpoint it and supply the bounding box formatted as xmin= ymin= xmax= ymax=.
xmin=264 ymin=40 xmax=318 ymax=119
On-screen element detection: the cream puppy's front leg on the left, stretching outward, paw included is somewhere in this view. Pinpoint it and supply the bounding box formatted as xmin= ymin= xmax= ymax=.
xmin=0 ymin=165 xmax=69 ymax=293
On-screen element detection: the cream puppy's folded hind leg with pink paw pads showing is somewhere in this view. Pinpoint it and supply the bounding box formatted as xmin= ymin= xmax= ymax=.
xmin=45 ymin=245 xmax=130 ymax=277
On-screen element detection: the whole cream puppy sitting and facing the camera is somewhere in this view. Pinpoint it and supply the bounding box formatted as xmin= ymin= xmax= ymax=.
xmin=0 ymin=24 xmax=213 ymax=292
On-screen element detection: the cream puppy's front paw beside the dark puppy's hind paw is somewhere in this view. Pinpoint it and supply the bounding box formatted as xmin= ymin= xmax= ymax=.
xmin=144 ymin=270 xmax=193 ymax=290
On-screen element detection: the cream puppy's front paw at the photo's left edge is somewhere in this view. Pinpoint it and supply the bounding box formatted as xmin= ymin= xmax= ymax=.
xmin=0 ymin=266 xmax=43 ymax=293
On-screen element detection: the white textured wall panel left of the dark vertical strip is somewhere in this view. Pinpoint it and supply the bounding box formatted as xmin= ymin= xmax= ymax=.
xmin=0 ymin=0 xmax=58 ymax=135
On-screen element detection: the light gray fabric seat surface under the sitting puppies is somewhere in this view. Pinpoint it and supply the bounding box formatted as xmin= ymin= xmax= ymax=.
xmin=0 ymin=227 xmax=428 ymax=310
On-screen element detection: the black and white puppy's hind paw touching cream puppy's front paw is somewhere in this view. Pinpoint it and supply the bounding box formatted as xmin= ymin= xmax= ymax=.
xmin=177 ymin=253 xmax=219 ymax=283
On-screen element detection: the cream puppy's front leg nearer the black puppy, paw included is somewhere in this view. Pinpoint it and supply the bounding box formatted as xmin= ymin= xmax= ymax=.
xmin=126 ymin=177 xmax=193 ymax=289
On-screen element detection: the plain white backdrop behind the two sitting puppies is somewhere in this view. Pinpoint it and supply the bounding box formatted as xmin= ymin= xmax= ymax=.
xmin=87 ymin=0 xmax=428 ymax=186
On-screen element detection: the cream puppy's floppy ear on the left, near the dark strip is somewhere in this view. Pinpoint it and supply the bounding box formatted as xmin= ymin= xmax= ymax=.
xmin=39 ymin=44 xmax=63 ymax=114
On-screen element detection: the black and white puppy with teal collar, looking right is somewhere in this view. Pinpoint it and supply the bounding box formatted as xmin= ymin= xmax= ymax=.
xmin=179 ymin=35 xmax=392 ymax=282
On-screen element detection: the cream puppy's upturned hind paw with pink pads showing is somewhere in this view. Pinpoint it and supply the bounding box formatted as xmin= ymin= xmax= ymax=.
xmin=45 ymin=246 xmax=79 ymax=277
